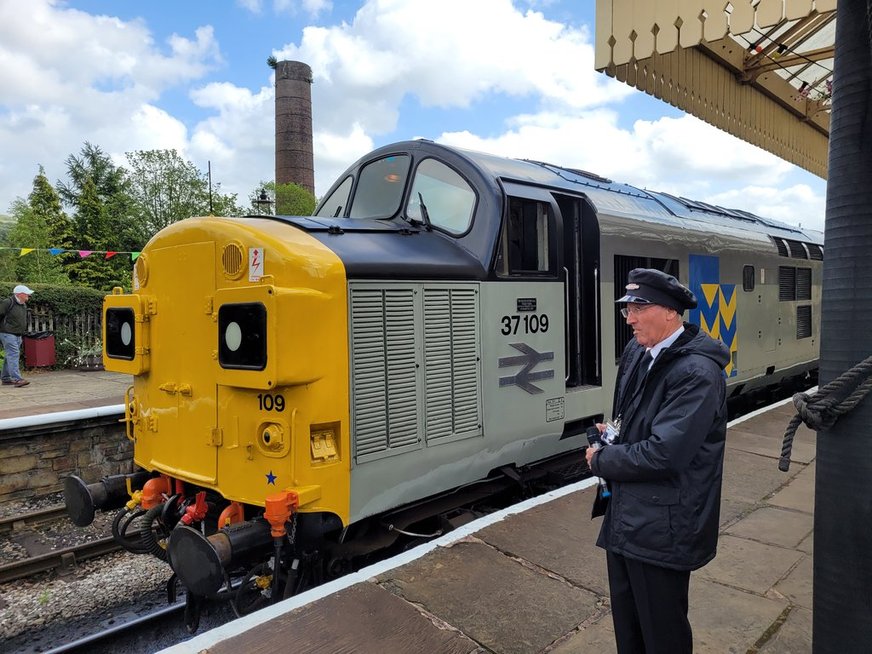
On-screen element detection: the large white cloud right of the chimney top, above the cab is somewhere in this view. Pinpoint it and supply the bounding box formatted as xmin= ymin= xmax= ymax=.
xmin=275 ymin=0 xmax=632 ymax=134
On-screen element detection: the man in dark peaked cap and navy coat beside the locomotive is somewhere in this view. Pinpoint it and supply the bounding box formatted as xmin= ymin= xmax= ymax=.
xmin=587 ymin=268 xmax=730 ymax=654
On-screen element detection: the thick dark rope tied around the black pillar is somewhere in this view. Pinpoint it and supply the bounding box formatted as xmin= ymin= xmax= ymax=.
xmin=778 ymin=356 xmax=872 ymax=472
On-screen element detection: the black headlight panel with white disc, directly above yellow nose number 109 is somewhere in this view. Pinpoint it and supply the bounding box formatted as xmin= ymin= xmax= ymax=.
xmin=218 ymin=302 xmax=267 ymax=370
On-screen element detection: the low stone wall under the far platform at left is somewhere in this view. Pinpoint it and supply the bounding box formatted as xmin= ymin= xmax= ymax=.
xmin=0 ymin=414 xmax=133 ymax=503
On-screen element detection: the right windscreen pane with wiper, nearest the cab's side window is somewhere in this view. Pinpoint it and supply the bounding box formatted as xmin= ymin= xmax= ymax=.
xmin=406 ymin=159 xmax=475 ymax=234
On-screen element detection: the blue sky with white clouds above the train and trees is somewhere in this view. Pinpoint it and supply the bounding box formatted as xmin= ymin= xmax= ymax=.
xmin=0 ymin=0 xmax=826 ymax=230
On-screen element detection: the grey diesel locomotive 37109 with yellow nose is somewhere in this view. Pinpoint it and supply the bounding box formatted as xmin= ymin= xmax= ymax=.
xmin=65 ymin=140 xmax=824 ymax=622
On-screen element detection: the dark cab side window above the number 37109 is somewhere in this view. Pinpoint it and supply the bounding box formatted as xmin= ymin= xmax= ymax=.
xmin=495 ymin=197 xmax=553 ymax=275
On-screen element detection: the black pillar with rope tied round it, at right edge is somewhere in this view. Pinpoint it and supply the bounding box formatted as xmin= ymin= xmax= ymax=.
xmin=812 ymin=0 xmax=872 ymax=654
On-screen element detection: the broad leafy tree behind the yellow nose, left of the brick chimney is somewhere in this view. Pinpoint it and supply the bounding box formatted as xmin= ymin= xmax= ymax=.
xmin=127 ymin=150 xmax=239 ymax=237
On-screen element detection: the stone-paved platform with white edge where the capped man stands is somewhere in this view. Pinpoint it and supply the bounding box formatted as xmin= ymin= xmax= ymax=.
xmin=163 ymin=402 xmax=816 ymax=654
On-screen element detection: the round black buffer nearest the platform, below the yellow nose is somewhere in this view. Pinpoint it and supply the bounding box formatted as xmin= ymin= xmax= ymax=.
xmin=167 ymin=518 xmax=273 ymax=596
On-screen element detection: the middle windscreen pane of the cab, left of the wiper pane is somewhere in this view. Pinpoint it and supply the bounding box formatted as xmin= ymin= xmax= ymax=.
xmin=348 ymin=154 xmax=410 ymax=218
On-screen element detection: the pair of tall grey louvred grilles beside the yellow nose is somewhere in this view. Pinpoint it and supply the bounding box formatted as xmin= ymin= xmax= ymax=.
xmin=350 ymin=284 xmax=481 ymax=463
